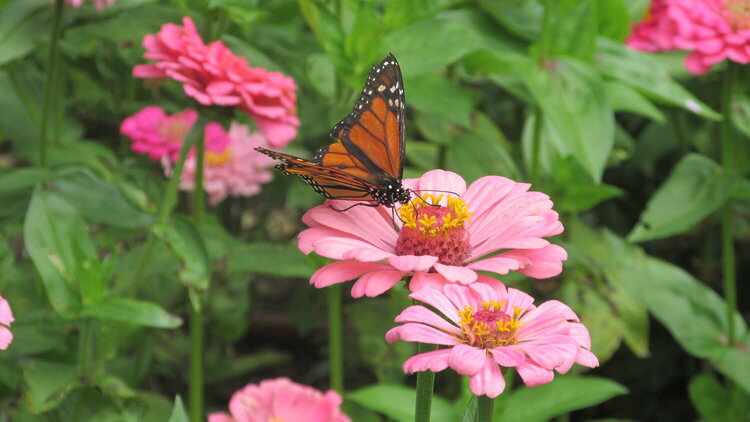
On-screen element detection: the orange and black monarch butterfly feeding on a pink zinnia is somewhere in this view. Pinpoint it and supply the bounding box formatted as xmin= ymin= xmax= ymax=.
xmin=255 ymin=54 xmax=410 ymax=209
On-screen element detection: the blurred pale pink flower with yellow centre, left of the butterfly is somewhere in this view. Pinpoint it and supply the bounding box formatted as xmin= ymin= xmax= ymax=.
xmin=167 ymin=123 xmax=273 ymax=205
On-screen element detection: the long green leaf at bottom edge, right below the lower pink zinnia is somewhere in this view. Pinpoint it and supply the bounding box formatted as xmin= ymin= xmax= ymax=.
xmin=494 ymin=375 xmax=628 ymax=422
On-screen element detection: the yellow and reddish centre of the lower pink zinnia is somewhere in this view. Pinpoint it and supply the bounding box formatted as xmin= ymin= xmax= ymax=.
xmin=456 ymin=302 xmax=523 ymax=349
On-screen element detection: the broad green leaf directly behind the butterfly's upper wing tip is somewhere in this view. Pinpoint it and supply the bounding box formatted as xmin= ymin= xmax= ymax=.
xmin=382 ymin=18 xmax=482 ymax=78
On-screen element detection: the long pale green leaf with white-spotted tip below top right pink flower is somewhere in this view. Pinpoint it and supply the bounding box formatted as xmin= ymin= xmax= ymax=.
xmin=594 ymin=38 xmax=721 ymax=120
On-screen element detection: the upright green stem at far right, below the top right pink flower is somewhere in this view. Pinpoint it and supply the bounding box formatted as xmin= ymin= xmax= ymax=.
xmin=721 ymin=61 xmax=739 ymax=344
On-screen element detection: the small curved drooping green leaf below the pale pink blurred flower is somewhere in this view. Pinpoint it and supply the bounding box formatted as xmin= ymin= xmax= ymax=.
xmin=153 ymin=215 xmax=211 ymax=290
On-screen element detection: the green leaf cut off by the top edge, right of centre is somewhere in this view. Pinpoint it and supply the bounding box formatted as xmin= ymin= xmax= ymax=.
xmin=479 ymin=0 xmax=544 ymax=41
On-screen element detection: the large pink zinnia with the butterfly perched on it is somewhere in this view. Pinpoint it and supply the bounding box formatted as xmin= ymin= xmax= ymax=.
xmin=299 ymin=170 xmax=567 ymax=297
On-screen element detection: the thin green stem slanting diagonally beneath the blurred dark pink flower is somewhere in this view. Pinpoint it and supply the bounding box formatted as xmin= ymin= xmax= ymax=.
xmin=128 ymin=118 xmax=204 ymax=296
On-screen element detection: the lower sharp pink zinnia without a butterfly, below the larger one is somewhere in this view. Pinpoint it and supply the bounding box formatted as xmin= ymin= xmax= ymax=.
xmin=386 ymin=283 xmax=599 ymax=398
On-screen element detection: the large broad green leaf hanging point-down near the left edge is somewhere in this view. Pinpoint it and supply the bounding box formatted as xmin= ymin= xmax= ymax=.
xmin=24 ymin=190 xmax=96 ymax=317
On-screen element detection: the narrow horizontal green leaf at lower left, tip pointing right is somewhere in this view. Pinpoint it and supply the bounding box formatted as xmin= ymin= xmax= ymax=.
xmin=80 ymin=297 xmax=182 ymax=328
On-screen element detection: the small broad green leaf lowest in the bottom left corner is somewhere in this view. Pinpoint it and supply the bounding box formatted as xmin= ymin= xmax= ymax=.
xmin=23 ymin=360 xmax=79 ymax=414
